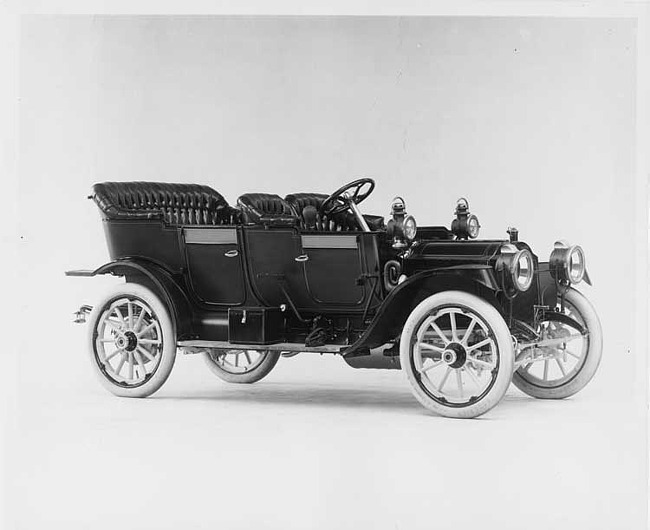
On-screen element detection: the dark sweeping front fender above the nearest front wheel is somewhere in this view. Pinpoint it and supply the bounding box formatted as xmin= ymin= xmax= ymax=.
xmin=343 ymin=265 xmax=502 ymax=357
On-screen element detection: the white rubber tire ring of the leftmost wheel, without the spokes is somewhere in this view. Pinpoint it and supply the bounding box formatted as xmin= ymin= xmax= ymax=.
xmin=88 ymin=282 xmax=176 ymax=398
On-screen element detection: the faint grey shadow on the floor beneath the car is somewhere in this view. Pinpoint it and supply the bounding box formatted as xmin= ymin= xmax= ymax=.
xmin=154 ymin=382 xmax=537 ymax=415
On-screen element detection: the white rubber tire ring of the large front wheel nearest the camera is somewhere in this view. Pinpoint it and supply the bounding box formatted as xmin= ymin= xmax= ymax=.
xmin=400 ymin=291 xmax=514 ymax=418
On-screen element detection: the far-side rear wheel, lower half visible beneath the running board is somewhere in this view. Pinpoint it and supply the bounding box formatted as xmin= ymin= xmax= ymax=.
xmin=203 ymin=349 xmax=280 ymax=383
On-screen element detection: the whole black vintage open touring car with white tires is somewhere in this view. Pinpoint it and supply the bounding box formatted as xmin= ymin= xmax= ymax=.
xmin=66 ymin=178 xmax=602 ymax=418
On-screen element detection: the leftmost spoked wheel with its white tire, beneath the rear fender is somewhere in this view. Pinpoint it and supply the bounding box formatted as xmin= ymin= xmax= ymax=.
xmin=89 ymin=283 xmax=176 ymax=397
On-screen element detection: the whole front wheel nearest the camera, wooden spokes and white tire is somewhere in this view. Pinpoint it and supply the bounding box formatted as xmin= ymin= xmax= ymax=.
xmin=400 ymin=291 xmax=514 ymax=418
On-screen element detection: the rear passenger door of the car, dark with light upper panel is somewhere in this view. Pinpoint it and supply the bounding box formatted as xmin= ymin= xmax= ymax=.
xmin=182 ymin=226 xmax=246 ymax=306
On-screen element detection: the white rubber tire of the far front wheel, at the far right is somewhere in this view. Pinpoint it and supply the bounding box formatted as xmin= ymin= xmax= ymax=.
xmin=512 ymin=289 xmax=603 ymax=399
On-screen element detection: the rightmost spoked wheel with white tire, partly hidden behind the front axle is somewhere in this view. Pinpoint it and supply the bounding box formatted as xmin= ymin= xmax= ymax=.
xmin=512 ymin=289 xmax=603 ymax=399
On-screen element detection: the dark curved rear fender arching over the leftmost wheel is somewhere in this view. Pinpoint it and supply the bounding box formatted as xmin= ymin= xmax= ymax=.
xmin=89 ymin=258 xmax=193 ymax=340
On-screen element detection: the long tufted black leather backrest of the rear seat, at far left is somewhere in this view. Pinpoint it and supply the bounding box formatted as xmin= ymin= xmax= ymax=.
xmin=90 ymin=182 xmax=240 ymax=225
